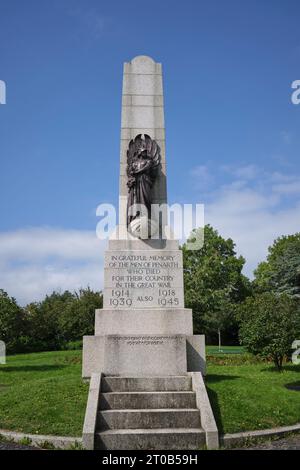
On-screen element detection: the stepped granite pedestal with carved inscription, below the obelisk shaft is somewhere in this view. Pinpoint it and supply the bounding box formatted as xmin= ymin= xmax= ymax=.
xmin=82 ymin=235 xmax=205 ymax=379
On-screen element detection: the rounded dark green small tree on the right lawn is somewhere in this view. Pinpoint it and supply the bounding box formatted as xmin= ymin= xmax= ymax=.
xmin=238 ymin=292 xmax=300 ymax=370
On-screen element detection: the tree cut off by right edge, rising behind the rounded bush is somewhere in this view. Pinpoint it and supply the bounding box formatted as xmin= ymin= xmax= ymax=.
xmin=254 ymin=233 xmax=300 ymax=298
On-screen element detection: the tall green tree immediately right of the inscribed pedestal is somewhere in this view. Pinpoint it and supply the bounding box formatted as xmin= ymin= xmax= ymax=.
xmin=182 ymin=225 xmax=251 ymax=341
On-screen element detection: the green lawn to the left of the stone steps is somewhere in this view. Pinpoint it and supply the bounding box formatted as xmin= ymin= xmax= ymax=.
xmin=0 ymin=351 xmax=88 ymax=436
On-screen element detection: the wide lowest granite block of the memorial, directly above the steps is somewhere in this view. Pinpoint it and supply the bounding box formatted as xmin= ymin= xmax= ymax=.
xmin=82 ymin=334 xmax=206 ymax=379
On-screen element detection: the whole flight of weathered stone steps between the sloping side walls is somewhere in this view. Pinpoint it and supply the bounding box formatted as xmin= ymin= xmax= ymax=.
xmin=95 ymin=375 xmax=205 ymax=450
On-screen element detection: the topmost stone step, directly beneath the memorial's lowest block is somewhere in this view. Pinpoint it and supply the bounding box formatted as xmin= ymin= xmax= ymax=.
xmin=101 ymin=375 xmax=192 ymax=392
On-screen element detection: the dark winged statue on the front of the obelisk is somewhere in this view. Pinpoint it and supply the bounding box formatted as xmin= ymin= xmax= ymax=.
xmin=127 ymin=134 xmax=161 ymax=227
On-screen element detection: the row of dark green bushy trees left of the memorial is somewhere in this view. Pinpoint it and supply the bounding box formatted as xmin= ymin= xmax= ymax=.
xmin=0 ymin=288 xmax=103 ymax=353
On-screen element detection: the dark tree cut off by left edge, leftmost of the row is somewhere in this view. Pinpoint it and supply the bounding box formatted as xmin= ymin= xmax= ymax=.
xmin=0 ymin=289 xmax=27 ymax=353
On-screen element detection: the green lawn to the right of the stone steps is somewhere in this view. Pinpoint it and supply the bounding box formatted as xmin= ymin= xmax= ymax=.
xmin=206 ymin=357 xmax=300 ymax=433
